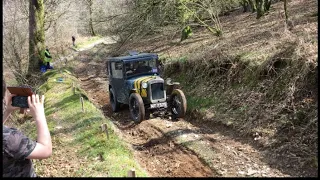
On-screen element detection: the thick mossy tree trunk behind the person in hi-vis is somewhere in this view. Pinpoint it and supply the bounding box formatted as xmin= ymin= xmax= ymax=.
xmin=27 ymin=0 xmax=45 ymax=77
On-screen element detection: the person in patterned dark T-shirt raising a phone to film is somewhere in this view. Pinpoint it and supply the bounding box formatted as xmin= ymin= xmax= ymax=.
xmin=2 ymin=80 xmax=52 ymax=177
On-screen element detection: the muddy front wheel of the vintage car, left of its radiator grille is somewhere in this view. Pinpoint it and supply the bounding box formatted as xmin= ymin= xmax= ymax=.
xmin=129 ymin=93 xmax=145 ymax=123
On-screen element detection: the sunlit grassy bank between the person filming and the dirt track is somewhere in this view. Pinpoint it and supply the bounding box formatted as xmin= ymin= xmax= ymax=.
xmin=22 ymin=71 xmax=147 ymax=177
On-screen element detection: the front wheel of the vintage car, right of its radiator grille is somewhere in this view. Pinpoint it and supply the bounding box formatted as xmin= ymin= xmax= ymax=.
xmin=169 ymin=89 xmax=187 ymax=119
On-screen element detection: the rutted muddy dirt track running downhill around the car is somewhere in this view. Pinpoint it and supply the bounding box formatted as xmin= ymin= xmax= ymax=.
xmin=75 ymin=45 xmax=290 ymax=177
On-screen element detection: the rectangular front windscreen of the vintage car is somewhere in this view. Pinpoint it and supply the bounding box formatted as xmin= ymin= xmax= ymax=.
xmin=125 ymin=59 xmax=158 ymax=77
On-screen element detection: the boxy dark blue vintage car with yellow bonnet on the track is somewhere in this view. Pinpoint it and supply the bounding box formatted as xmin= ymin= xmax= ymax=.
xmin=107 ymin=52 xmax=187 ymax=123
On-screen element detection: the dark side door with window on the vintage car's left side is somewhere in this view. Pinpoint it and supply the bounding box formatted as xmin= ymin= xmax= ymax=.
xmin=110 ymin=61 xmax=126 ymax=103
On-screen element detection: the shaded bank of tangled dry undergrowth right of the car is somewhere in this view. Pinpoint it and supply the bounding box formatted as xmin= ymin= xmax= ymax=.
xmin=164 ymin=36 xmax=318 ymax=176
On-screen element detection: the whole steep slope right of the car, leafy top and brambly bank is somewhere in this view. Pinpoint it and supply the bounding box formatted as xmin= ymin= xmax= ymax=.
xmin=110 ymin=0 xmax=318 ymax=176
